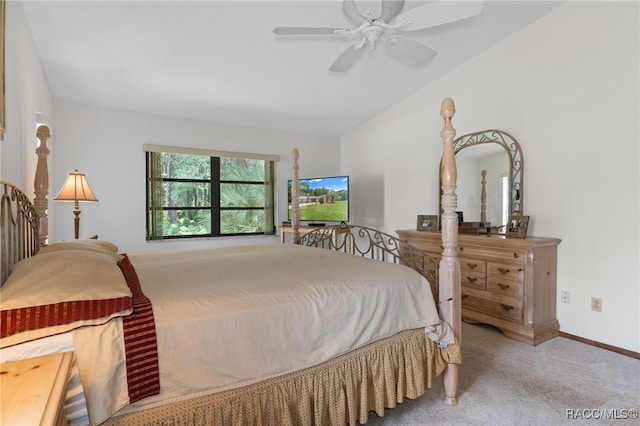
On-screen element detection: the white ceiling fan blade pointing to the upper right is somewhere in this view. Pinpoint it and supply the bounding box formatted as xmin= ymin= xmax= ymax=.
xmin=396 ymin=0 xmax=483 ymax=31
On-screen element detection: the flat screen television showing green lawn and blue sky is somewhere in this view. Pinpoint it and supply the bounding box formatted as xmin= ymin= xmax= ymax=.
xmin=287 ymin=176 xmax=349 ymax=225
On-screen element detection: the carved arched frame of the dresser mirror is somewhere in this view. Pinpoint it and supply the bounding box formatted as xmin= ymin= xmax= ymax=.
xmin=440 ymin=130 xmax=524 ymax=223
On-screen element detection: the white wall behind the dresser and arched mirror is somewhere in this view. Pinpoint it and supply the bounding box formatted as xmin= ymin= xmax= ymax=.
xmin=341 ymin=2 xmax=640 ymax=352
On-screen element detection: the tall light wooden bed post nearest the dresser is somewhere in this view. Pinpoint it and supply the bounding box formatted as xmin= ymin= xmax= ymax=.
xmin=439 ymin=98 xmax=462 ymax=405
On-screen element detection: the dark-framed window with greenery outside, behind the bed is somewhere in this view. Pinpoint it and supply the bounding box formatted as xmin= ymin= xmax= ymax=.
xmin=144 ymin=145 xmax=278 ymax=240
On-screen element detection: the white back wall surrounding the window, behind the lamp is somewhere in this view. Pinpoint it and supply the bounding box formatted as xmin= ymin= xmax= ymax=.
xmin=50 ymin=102 xmax=340 ymax=252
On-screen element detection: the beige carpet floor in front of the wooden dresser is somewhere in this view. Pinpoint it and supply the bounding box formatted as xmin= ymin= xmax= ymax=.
xmin=367 ymin=324 xmax=640 ymax=426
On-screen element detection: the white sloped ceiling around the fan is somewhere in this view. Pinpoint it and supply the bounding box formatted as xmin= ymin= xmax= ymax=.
xmin=22 ymin=0 xmax=558 ymax=136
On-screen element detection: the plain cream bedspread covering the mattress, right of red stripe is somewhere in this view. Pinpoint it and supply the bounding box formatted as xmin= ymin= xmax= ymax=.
xmin=114 ymin=244 xmax=440 ymax=413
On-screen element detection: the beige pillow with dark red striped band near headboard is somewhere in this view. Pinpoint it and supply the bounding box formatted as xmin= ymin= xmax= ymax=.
xmin=0 ymin=251 xmax=132 ymax=347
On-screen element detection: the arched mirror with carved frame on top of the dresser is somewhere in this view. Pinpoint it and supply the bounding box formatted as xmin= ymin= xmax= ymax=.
xmin=440 ymin=130 xmax=524 ymax=231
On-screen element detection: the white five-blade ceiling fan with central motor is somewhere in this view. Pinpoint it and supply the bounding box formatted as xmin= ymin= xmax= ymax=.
xmin=273 ymin=0 xmax=483 ymax=72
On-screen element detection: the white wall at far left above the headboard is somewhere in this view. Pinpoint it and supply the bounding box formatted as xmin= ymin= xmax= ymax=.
xmin=0 ymin=1 xmax=55 ymax=197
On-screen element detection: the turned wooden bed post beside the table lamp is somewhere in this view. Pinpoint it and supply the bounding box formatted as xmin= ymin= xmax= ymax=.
xmin=33 ymin=124 xmax=51 ymax=247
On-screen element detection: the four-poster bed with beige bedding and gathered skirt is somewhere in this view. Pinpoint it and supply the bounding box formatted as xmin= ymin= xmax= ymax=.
xmin=0 ymin=99 xmax=461 ymax=425
